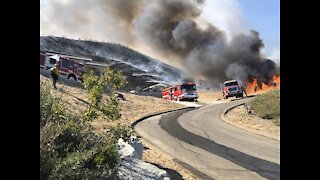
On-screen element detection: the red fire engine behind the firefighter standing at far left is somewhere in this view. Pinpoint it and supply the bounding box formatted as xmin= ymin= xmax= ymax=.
xmin=40 ymin=52 xmax=91 ymax=82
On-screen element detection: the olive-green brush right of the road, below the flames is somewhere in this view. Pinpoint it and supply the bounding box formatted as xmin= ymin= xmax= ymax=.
xmin=249 ymin=90 xmax=280 ymax=126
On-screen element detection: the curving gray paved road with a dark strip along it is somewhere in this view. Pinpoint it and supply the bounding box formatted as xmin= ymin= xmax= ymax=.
xmin=135 ymin=99 xmax=280 ymax=179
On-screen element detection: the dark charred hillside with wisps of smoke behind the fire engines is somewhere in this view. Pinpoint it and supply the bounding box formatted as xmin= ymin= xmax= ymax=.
xmin=40 ymin=36 xmax=187 ymax=88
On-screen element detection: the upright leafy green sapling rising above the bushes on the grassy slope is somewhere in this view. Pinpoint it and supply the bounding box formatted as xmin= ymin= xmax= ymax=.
xmin=84 ymin=66 xmax=127 ymax=121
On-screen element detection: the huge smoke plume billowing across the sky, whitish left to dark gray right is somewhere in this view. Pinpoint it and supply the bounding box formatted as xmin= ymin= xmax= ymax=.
xmin=42 ymin=0 xmax=278 ymax=85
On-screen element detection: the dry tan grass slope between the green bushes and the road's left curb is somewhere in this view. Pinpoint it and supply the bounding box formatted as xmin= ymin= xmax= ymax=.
xmin=40 ymin=75 xmax=185 ymax=130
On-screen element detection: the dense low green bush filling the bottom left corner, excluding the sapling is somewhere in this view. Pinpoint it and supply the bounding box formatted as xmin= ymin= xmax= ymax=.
xmin=40 ymin=83 xmax=118 ymax=179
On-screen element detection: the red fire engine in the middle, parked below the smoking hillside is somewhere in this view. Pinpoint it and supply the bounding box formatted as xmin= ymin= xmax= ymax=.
xmin=162 ymin=83 xmax=199 ymax=101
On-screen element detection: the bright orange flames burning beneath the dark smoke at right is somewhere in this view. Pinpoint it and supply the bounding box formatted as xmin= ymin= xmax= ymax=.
xmin=246 ymin=75 xmax=280 ymax=94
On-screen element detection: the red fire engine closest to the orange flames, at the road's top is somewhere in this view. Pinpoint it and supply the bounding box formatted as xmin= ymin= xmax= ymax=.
xmin=220 ymin=80 xmax=243 ymax=99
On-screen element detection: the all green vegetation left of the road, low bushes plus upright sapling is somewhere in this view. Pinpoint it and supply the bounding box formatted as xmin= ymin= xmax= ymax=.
xmin=40 ymin=68 xmax=134 ymax=179
